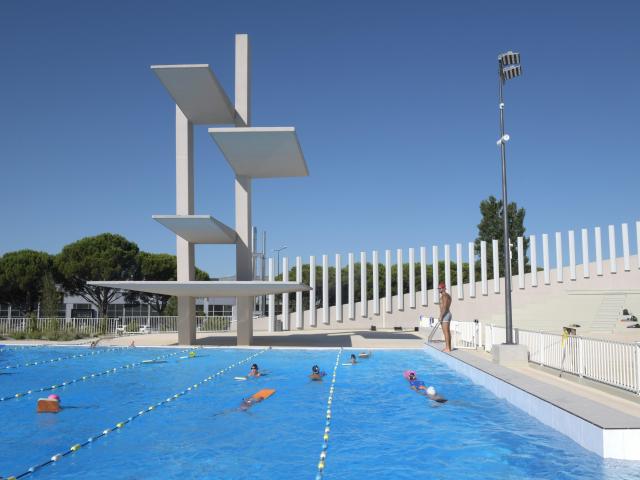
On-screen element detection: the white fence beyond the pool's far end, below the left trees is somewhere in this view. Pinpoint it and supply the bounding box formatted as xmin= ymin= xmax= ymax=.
xmin=0 ymin=316 xmax=236 ymax=336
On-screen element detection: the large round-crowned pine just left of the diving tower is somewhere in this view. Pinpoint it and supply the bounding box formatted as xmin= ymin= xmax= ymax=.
xmin=55 ymin=233 xmax=140 ymax=317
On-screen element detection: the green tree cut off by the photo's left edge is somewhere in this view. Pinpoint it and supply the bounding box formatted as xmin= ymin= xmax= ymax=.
xmin=0 ymin=250 xmax=53 ymax=314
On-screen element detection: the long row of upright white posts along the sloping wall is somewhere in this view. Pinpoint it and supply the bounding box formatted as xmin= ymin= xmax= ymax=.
xmin=268 ymin=221 xmax=640 ymax=331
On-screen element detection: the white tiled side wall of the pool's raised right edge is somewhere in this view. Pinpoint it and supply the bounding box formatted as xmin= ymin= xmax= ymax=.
xmin=423 ymin=344 xmax=640 ymax=461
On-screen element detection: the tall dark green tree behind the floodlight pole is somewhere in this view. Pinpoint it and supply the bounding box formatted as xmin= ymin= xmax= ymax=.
xmin=476 ymin=195 xmax=529 ymax=278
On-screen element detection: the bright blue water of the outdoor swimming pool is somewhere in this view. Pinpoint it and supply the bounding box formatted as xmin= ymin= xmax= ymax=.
xmin=0 ymin=347 xmax=640 ymax=479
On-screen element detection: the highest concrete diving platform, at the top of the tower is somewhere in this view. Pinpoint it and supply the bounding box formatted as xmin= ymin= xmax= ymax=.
xmin=151 ymin=65 xmax=236 ymax=125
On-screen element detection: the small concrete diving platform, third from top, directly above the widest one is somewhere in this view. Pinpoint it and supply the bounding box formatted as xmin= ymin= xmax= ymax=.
xmin=152 ymin=215 xmax=238 ymax=244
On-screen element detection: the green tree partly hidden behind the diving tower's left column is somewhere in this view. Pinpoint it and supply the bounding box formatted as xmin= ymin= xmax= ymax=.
xmin=132 ymin=252 xmax=209 ymax=315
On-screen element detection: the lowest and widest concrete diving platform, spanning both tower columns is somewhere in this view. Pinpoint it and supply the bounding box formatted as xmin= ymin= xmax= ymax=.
xmin=87 ymin=281 xmax=310 ymax=298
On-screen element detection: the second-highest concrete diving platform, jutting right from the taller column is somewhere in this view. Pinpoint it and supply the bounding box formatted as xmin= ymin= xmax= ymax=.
xmin=209 ymin=127 xmax=309 ymax=178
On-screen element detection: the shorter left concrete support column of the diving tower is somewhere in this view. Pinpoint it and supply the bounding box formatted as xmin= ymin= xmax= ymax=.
xmin=176 ymin=105 xmax=196 ymax=345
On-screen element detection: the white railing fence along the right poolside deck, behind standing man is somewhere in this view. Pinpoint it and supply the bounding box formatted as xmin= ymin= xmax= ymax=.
xmin=451 ymin=322 xmax=640 ymax=395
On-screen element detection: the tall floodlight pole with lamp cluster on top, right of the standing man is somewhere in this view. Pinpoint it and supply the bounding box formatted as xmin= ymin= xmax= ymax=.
xmin=496 ymin=50 xmax=522 ymax=345
